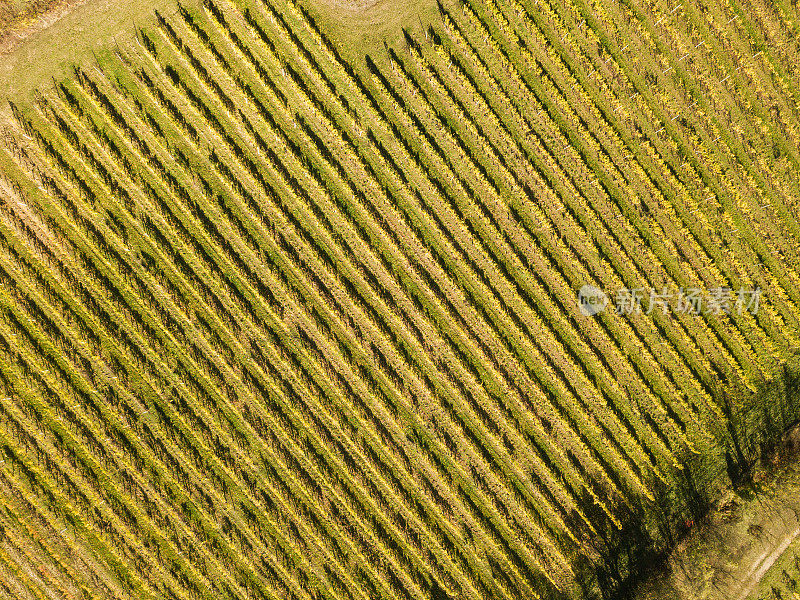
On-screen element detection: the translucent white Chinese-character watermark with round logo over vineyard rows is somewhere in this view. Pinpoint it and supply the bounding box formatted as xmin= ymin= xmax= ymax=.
xmin=578 ymin=285 xmax=762 ymax=317
